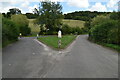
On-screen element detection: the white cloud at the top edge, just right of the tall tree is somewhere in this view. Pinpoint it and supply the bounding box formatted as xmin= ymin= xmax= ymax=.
xmin=67 ymin=0 xmax=89 ymax=8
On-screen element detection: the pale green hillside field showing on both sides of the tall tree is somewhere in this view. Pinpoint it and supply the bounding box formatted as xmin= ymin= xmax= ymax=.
xmin=28 ymin=19 xmax=85 ymax=35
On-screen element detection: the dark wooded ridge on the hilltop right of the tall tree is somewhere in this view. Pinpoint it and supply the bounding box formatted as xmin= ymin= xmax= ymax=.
xmin=64 ymin=11 xmax=110 ymax=21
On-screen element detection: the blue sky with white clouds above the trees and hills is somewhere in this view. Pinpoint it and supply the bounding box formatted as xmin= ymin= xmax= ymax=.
xmin=0 ymin=0 xmax=120 ymax=14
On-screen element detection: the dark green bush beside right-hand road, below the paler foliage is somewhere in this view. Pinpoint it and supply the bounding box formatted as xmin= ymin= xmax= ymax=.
xmin=90 ymin=20 xmax=118 ymax=43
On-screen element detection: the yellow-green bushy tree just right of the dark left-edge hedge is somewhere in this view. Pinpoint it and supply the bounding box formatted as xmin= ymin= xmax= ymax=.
xmin=11 ymin=15 xmax=31 ymax=36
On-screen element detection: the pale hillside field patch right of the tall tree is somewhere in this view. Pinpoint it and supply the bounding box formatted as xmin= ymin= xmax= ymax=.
xmin=63 ymin=19 xmax=85 ymax=28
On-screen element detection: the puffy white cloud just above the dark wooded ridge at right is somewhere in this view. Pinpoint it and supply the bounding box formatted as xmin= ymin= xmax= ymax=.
xmin=88 ymin=3 xmax=107 ymax=12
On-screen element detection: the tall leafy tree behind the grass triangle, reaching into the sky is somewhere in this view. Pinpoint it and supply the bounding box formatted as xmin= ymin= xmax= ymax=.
xmin=35 ymin=1 xmax=63 ymax=34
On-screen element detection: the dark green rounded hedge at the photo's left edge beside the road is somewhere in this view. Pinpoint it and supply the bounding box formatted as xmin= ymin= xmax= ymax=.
xmin=2 ymin=17 xmax=19 ymax=46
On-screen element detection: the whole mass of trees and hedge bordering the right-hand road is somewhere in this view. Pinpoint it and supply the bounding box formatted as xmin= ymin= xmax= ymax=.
xmin=85 ymin=12 xmax=120 ymax=50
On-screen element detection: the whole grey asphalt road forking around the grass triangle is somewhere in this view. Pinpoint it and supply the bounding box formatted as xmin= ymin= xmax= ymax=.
xmin=2 ymin=35 xmax=118 ymax=78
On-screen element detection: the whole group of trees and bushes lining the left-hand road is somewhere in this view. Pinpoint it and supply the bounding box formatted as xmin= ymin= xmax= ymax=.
xmin=0 ymin=14 xmax=31 ymax=47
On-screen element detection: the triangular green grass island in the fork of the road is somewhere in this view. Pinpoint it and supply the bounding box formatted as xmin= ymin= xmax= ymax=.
xmin=38 ymin=35 xmax=76 ymax=49
